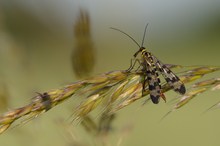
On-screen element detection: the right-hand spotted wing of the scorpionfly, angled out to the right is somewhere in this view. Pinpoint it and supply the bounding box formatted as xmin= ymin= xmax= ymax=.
xmin=152 ymin=56 xmax=186 ymax=94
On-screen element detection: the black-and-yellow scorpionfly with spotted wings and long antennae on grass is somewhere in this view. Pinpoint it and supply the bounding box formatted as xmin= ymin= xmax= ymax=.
xmin=111 ymin=24 xmax=186 ymax=104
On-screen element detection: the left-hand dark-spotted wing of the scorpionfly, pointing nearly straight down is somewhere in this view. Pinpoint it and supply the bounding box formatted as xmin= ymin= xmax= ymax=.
xmin=144 ymin=60 xmax=165 ymax=104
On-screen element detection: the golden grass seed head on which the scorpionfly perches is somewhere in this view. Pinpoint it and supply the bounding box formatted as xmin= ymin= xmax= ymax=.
xmin=0 ymin=66 xmax=220 ymax=133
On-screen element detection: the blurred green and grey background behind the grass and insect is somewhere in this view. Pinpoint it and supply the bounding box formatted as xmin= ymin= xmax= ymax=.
xmin=0 ymin=0 xmax=220 ymax=146
